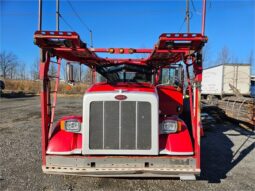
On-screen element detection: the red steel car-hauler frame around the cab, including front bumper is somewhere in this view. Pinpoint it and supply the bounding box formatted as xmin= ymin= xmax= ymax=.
xmin=34 ymin=1 xmax=207 ymax=178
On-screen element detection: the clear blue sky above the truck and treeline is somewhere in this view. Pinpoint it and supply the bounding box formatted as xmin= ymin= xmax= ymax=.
xmin=0 ymin=0 xmax=255 ymax=74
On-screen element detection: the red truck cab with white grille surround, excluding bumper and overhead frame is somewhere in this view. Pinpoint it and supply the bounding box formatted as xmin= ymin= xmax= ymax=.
xmin=46 ymin=65 xmax=194 ymax=155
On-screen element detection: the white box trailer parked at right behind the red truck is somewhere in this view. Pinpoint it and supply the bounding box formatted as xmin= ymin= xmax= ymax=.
xmin=202 ymin=64 xmax=251 ymax=97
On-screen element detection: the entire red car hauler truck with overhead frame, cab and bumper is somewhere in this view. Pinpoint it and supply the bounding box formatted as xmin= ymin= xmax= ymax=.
xmin=34 ymin=1 xmax=207 ymax=179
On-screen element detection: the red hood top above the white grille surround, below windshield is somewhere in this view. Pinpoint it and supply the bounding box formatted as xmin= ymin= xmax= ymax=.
xmin=86 ymin=82 xmax=156 ymax=93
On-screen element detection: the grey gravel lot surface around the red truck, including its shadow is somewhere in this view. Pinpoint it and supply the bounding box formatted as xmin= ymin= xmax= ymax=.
xmin=0 ymin=96 xmax=255 ymax=190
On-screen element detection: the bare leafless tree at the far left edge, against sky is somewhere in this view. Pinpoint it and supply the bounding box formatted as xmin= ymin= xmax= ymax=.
xmin=0 ymin=51 xmax=18 ymax=79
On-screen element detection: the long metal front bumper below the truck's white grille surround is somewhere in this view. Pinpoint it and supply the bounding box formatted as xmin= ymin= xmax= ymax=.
xmin=42 ymin=156 xmax=200 ymax=180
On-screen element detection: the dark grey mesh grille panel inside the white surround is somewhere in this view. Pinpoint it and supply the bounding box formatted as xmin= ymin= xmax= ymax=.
xmin=89 ymin=101 xmax=151 ymax=150
